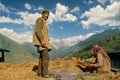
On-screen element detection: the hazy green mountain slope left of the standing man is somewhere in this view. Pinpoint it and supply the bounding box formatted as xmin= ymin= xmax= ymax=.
xmin=0 ymin=34 xmax=36 ymax=63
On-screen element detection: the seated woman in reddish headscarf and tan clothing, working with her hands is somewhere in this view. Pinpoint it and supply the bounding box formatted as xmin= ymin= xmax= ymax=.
xmin=88 ymin=45 xmax=111 ymax=73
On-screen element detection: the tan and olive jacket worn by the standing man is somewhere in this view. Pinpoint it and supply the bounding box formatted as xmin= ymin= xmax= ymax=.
xmin=32 ymin=17 xmax=52 ymax=51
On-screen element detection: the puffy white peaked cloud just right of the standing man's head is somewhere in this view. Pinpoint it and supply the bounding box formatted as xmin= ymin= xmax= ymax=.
xmin=48 ymin=3 xmax=77 ymax=24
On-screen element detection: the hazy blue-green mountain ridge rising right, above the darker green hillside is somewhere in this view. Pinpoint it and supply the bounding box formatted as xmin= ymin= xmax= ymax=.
xmin=58 ymin=29 xmax=120 ymax=57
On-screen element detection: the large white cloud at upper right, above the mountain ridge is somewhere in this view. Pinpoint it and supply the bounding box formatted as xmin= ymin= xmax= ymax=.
xmin=81 ymin=2 xmax=120 ymax=29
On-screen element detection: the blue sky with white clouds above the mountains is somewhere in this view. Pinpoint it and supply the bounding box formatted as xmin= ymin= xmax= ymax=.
xmin=0 ymin=0 xmax=120 ymax=49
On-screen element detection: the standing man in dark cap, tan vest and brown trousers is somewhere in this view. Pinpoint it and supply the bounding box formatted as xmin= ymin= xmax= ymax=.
xmin=33 ymin=10 xmax=51 ymax=78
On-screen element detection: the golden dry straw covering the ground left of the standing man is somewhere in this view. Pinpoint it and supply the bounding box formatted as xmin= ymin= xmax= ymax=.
xmin=0 ymin=62 xmax=42 ymax=80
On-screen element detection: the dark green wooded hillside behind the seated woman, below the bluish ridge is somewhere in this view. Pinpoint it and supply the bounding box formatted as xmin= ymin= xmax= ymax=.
xmin=70 ymin=35 xmax=120 ymax=59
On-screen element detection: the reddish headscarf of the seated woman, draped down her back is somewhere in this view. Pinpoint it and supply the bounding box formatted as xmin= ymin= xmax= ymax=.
xmin=91 ymin=45 xmax=110 ymax=61
